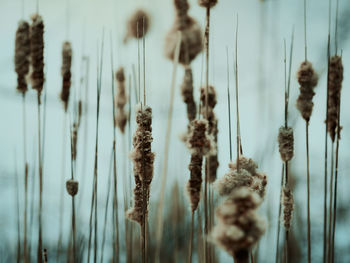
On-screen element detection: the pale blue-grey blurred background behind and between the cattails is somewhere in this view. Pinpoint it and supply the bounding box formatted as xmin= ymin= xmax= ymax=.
xmin=0 ymin=0 xmax=350 ymax=262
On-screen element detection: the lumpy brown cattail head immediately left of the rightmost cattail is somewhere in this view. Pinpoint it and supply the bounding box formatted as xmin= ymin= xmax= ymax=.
xmin=297 ymin=61 xmax=318 ymax=122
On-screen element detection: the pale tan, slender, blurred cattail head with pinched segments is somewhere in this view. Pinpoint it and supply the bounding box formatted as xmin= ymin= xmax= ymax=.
xmin=114 ymin=67 xmax=128 ymax=133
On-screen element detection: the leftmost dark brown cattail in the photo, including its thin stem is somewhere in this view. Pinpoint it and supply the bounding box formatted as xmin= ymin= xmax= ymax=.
xmin=14 ymin=20 xmax=30 ymax=262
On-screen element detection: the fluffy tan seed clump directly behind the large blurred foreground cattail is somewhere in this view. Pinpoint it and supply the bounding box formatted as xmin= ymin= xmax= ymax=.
xmin=215 ymin=156 xmax=267 ymax=198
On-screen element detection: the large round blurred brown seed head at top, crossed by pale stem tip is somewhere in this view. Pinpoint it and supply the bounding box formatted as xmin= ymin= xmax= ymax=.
xmin=165 ymin=17 xmax=203 ymax=65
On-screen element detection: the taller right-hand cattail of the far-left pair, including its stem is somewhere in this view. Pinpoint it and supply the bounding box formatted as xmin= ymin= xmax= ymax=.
xmin=30 ymin=14 xmax=45 ymax=263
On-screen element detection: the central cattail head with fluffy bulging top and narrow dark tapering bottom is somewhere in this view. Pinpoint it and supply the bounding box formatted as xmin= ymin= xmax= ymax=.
xmin=187 ymin=120 xmax=213 ymax=212
